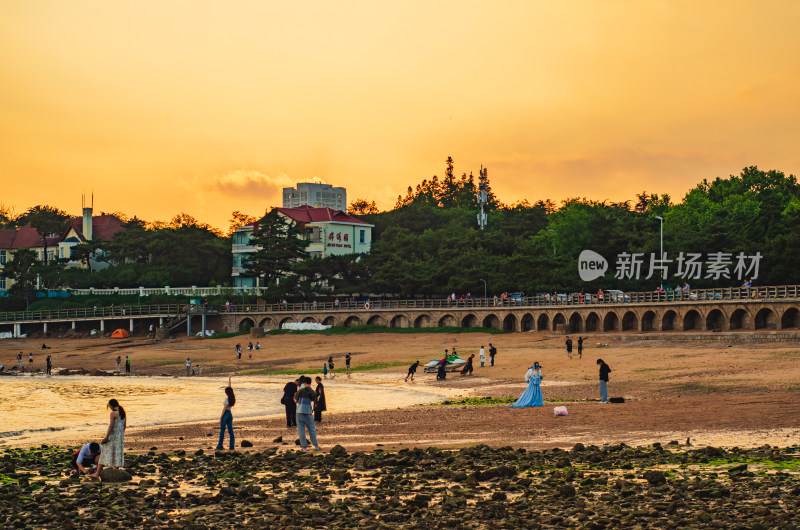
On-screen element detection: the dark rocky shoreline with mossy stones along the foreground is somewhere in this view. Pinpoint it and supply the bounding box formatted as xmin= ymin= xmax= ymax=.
xmin=0 ymin=442 xmax=800 ymax=528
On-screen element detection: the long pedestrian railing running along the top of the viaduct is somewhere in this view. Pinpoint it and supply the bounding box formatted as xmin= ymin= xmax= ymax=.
xmin=0 ymin=285 xmax=800 ymax=322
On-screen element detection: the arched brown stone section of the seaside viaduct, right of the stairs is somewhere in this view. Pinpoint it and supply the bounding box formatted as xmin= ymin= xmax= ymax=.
xmin=220 ymin=291 xmax=800 ymax=333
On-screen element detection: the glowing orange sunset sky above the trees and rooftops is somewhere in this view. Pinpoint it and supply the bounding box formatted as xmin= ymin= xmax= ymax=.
xmin=0 ymin=0 xmax=800 ymax=228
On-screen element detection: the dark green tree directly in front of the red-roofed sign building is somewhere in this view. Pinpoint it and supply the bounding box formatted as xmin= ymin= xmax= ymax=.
xmin=244 ymin=208 xmax=309 ymax=286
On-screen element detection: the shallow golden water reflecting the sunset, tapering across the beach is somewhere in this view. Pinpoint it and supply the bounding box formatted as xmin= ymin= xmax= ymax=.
xmin=0 ymin=376 xmax=446 ymax=446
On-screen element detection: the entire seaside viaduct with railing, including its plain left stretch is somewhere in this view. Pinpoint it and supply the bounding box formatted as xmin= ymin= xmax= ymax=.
xmin=0 ymin=285 xmax=800 ymax=336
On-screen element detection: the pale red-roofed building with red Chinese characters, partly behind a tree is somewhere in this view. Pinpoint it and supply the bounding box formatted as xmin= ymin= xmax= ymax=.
xmin=231 ymin=206 xmax=374 ymax=287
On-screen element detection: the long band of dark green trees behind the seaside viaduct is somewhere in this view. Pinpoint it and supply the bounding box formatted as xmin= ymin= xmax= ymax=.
xmin=0 ymin=158 xmax=800 ymax=310
